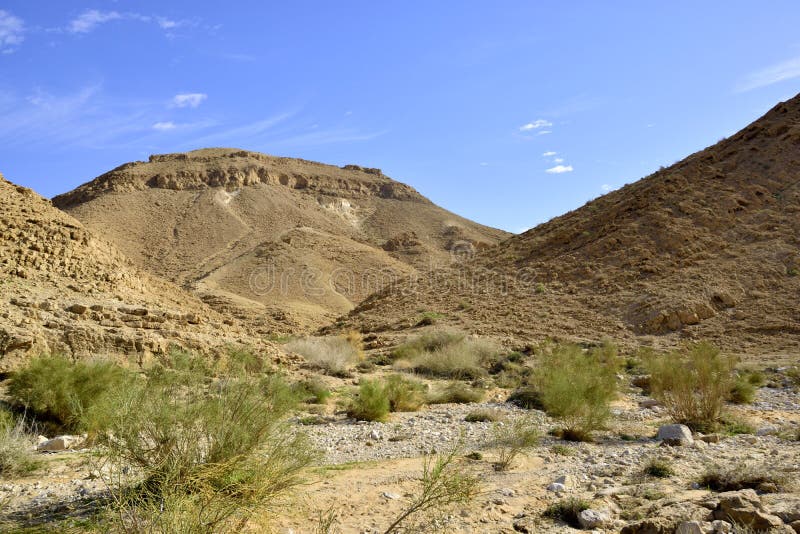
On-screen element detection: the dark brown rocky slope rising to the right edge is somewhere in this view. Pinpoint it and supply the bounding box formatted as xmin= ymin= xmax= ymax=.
xmin=346 ymin=96 xmax=800 ymax=351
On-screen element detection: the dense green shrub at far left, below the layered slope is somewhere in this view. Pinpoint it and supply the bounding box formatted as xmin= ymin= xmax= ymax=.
xmin=8 ymin=356 xmax=134 ymax=432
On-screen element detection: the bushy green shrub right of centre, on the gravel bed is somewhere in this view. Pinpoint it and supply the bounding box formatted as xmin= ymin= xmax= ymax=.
xmin=534 ymin=345 xmax=617 ymax=441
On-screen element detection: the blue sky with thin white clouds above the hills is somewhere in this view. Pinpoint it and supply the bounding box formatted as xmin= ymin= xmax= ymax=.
xmin=0 ymin=0 xmax=800 ymax=231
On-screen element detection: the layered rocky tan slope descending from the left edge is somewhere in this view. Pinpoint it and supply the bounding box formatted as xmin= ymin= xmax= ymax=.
xmin=0 ymin=175 xmax=274 ymax=371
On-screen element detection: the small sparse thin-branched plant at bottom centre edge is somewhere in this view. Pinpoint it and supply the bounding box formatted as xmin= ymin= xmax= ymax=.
xmin=384 ymin=447 xmax=480 ymax=534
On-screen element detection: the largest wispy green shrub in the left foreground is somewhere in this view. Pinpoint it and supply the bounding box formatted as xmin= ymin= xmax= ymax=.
xmin=93 ymin=370 xmax=315 ymax=532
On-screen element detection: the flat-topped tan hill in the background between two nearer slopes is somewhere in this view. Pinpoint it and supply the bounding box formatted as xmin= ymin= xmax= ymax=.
xmin=53 ymin=149 xmax=507 ymax=332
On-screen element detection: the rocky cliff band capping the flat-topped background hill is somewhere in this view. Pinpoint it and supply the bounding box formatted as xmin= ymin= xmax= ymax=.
xmin=53 ymin=149 xmax=429 ymax=209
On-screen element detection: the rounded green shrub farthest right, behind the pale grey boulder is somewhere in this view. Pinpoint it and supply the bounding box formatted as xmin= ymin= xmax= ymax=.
xmin=646 ymin=342 xmax=736 ymax=432
